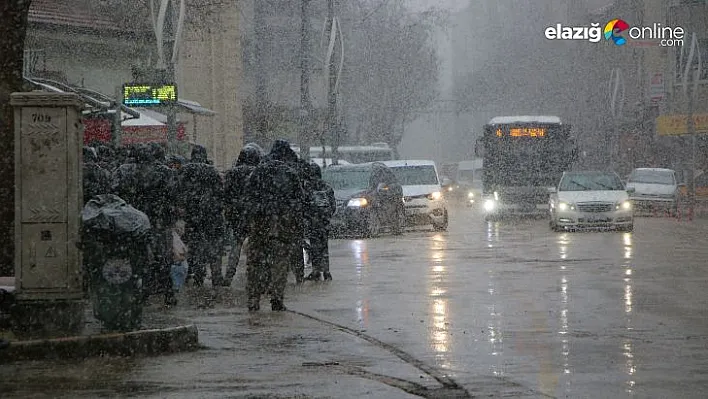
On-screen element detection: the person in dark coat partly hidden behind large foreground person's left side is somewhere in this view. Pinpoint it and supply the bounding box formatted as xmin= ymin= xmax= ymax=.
xmin=224 ymin=143 xmax=264 ymax=286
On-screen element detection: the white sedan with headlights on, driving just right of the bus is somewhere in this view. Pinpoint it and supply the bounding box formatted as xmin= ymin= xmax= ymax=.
xmin=549 ymin=171 xmax=634 ymax=231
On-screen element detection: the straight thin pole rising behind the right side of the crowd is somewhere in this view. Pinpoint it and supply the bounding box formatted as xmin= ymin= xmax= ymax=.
xmin=298 ymin=0 xmax=312 ymax=161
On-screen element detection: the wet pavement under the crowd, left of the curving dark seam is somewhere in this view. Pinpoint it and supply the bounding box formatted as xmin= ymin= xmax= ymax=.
xmin=0 ymin=283 xmax=476 ymax=399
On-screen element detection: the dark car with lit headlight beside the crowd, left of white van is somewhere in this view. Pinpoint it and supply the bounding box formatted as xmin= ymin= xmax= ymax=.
xmin=322 ymin=162 xmax=405 ymax=237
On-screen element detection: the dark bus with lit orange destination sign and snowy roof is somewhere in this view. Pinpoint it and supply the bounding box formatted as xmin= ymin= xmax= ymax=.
xmin=475 ymin=116 xmax=577 ymax=219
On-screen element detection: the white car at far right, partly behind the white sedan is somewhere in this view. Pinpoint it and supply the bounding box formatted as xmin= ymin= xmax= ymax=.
xmin=627 ymin=168 xmax=680 ymax=212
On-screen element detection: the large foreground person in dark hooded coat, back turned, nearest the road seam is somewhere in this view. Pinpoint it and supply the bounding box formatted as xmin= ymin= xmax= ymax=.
xmin=246 ymin=140 xmax=304 ymax=311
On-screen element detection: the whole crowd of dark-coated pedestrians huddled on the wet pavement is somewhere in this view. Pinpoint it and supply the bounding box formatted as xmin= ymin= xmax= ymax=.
xmin=84 ymin=140 xmax=336 ymax=311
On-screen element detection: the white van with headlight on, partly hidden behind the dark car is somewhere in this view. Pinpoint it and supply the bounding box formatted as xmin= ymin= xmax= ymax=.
xmin=382 ymin=160 xmax=448 ymax=231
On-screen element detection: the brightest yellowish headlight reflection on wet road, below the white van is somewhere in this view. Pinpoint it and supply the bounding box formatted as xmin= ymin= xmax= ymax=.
xmin=428 ymin=234 xmax=451 ymax=369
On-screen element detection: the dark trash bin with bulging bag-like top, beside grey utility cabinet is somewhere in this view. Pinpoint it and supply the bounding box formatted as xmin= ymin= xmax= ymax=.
xmin=81 ymin=194 xmax=150 ymax=331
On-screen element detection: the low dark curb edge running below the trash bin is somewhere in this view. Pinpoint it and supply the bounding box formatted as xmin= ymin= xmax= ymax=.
xmin=0 ymin=324 xmax=200 ymax=364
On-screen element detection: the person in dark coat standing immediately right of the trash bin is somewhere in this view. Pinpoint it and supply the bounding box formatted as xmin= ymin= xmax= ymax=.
xmin=112 ymin=145 xmax=176 ymax=305
